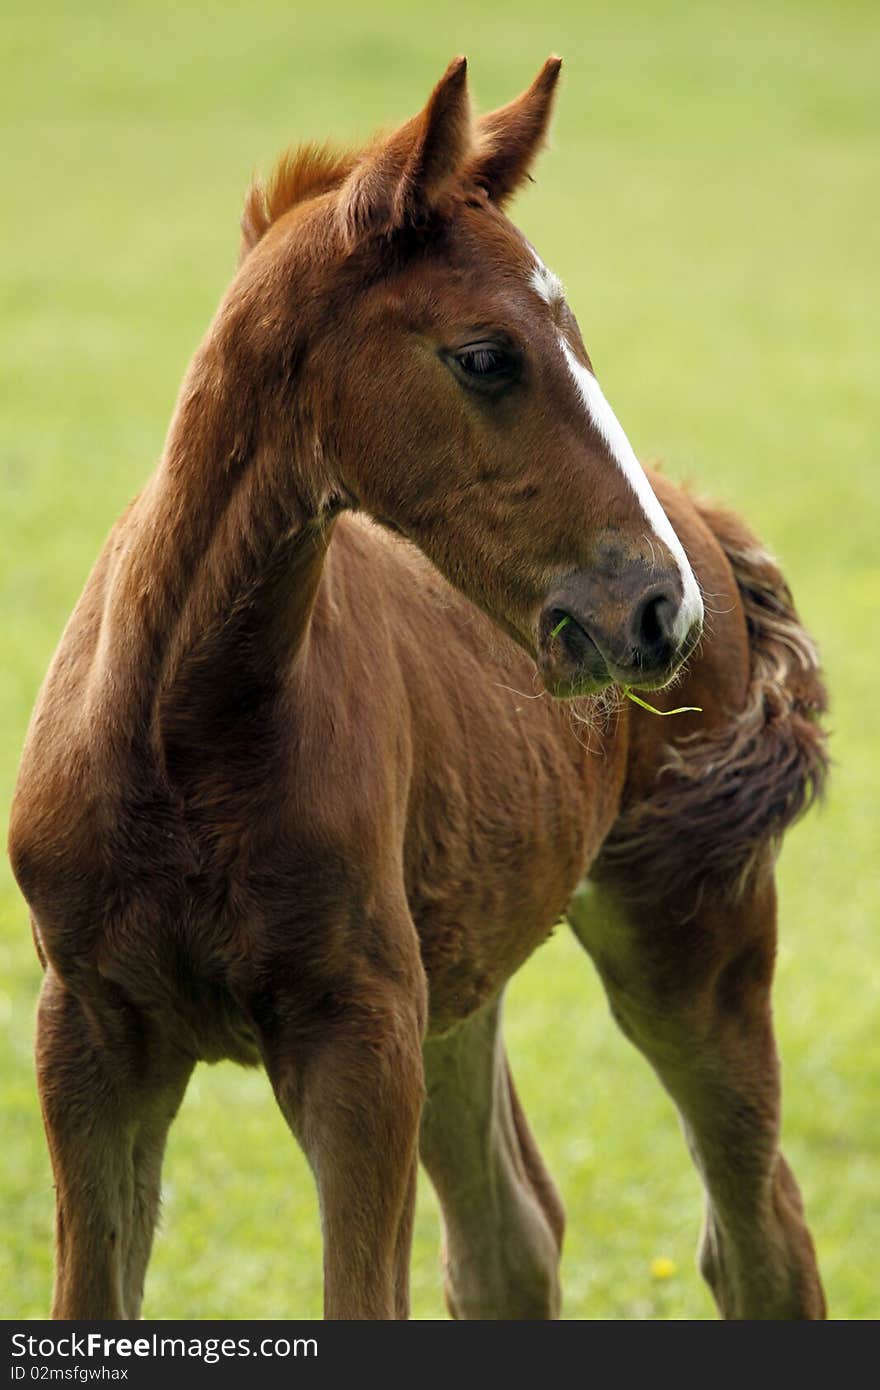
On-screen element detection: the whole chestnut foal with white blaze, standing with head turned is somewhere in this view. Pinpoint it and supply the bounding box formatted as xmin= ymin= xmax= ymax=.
xmin=11 ymin=60 xmax=824 ymax=1318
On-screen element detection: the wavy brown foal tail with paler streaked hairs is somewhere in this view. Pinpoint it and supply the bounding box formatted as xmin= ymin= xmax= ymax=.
xmin=594 ymin=499 xmax=829 ymax=906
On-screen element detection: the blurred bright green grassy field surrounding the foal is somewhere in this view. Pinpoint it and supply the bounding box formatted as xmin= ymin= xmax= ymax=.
xmin=0 ymin=0 xmax=880 ymax=1319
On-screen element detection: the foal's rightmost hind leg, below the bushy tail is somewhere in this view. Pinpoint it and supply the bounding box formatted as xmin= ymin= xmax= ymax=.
xmin=569 ymin=865 xmax=824 ymax=1319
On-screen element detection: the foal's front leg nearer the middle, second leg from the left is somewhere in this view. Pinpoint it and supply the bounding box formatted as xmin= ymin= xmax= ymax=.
xmin=263 ymin=923 xmax=425 ymax=1319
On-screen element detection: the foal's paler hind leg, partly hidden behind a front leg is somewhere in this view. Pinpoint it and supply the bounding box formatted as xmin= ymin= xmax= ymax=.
xmin=420 ymin=1001 xmax=564 ymax=1319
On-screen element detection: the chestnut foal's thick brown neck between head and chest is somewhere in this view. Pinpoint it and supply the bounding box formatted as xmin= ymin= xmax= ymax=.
xmin=93 ymin=326 xmax=332 ymax=758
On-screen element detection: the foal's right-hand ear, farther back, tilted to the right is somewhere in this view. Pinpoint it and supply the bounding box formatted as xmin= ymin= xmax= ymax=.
xmin=467 ymin=58 xmax=562 ymax=206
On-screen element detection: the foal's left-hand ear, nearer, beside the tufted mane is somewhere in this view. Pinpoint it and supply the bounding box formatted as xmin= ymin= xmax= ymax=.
xmin=339 ymin=58 xmax=473 ymax=245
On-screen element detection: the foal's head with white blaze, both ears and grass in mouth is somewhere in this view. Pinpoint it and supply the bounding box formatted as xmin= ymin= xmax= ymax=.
xmin=233 ymin=58 xmax=702 ymax=696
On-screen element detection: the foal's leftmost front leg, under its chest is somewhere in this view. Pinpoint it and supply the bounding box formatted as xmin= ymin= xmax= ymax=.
xmin=36 ymin=970 xmax=192 ymax=1319
